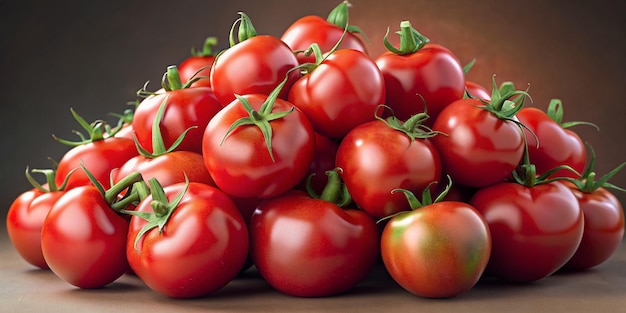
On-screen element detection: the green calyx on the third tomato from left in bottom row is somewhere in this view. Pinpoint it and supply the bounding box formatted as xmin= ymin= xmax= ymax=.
xmin=123 ymin=175 xmax=189 ymax=253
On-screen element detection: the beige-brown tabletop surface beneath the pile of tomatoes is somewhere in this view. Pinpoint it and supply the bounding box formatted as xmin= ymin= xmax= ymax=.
xmin=0 ymin=229 xmax=626 ymax=313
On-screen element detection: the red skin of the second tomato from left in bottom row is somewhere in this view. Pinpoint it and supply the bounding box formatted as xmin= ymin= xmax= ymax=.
xmin=41 ymin=185 xmax=129 ymax=289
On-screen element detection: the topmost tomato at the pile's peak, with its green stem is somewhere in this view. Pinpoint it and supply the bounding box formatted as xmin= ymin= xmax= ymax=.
xmin=280 ymin=2 xmax=367 ymax=64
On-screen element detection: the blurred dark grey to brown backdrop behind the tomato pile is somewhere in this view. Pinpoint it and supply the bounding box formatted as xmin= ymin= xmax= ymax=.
xmin=0 ymin=0 xmax=626 ymax=219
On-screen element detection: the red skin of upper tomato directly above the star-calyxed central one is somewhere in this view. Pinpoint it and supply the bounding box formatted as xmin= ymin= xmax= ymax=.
xmin=210 ymin=35 xmax=300 ymax=105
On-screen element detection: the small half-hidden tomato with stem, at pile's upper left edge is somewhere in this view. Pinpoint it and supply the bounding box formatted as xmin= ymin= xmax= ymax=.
xmin=178 ymin=37 xmax=217 ymax=88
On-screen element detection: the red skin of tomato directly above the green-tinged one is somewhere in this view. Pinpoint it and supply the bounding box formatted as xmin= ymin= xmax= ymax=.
xmin=336 ymin=120 xmax=442 ymax=219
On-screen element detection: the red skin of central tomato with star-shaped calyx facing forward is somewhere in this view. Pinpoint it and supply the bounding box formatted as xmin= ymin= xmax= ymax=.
xmin=203 ymin=94 xmax=315 ymax=198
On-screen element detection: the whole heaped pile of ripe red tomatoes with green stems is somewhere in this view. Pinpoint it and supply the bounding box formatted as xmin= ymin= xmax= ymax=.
xmin=7 ymin=2 xmax=625 ymax=298
